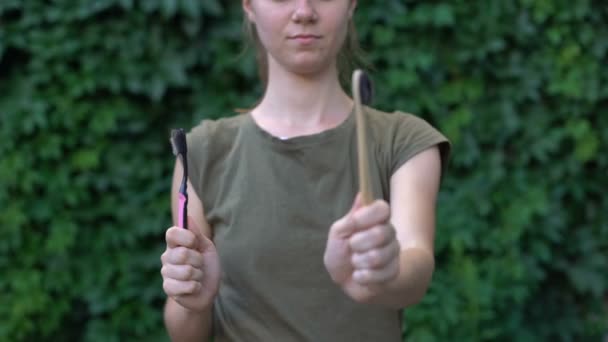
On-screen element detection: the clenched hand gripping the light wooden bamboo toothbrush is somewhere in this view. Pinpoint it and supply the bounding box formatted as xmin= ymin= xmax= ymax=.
xmin=323 ymin=195 xmax=401 ymax=303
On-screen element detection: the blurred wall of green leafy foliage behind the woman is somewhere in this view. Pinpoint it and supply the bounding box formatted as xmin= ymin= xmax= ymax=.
xmin=0 ymin=0 xmax=608 ymax=342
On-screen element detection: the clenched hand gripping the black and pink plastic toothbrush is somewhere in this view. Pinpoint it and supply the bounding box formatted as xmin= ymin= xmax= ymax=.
xmin=160 ymin=217 xmax=220 ymax=312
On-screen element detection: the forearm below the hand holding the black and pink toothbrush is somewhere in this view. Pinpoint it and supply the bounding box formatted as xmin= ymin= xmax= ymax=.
xmin=164 ymin=298 xmax=213 ymax=342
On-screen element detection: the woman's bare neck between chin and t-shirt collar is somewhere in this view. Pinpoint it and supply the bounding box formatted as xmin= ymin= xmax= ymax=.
xmin=252 ymin=60 xmax=353 ymax=136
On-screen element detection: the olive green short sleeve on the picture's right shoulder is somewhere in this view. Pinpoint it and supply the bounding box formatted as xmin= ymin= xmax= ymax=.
xmin=391 ymin=112 xmax=451 ymax=178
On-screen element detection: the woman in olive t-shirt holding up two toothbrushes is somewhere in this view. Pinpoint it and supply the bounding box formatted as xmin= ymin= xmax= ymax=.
xmin=161 ymin=0 xmax=449 ymax=341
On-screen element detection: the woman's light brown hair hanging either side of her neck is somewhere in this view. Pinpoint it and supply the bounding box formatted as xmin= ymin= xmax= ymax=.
xmin=238 ymin=12 xmax=370 ymax=112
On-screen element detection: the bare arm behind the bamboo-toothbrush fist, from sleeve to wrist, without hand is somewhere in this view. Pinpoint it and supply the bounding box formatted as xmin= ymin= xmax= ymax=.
xmin=374 ymin=147 xmax=441 ymax=308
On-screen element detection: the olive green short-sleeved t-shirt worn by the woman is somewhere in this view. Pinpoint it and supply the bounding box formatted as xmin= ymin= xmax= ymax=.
xmin=187 ymin=108 xmax=449 ymax=342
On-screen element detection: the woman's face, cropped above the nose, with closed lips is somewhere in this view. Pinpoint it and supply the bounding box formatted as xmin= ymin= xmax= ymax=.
xmin=243 ymin=0 xmax=356 ymax=74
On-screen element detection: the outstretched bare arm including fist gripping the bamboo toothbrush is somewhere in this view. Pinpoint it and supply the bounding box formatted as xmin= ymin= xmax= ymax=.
xmin=324 ymin=147 xmax=441 ymax=308
